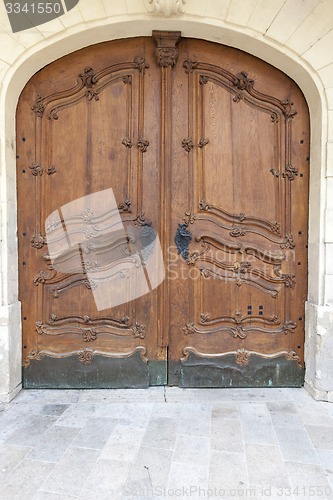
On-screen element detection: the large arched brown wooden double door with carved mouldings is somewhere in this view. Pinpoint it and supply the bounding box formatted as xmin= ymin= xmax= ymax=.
xmin=17 ymin=32 xmax=309 ymax=388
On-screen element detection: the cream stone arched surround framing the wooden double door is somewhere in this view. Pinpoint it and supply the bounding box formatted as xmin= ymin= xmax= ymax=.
xmin=0 ymin=20 xmax=327 ymax=399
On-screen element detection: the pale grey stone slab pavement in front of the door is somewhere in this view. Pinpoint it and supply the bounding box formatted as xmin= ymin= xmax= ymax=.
xmin=0 ymin=387 xmax=333 ymax=500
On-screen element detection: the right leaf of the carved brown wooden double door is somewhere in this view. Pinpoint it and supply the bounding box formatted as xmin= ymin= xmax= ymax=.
xmin=169 ymin=40 xmax=309 ymax=386
